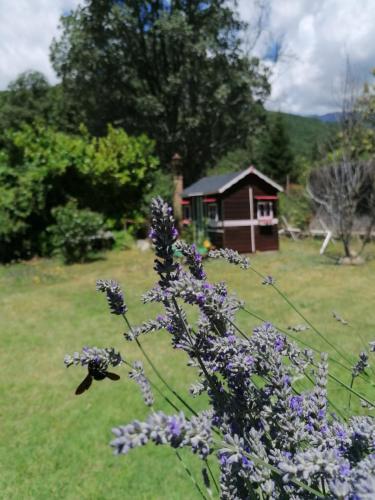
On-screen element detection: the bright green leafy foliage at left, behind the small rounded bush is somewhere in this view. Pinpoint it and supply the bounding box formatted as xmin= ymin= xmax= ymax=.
xmin=0 ymin=125 xmax=158 ymax=260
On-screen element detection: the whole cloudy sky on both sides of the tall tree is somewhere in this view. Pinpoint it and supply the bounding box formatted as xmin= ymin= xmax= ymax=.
xmin=0 ymin=0 xmax=375 ymax=114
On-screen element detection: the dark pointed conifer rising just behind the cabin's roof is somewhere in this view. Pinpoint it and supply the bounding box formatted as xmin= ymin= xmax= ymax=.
xmin=258 ymin=113 xmax=294 ymax=184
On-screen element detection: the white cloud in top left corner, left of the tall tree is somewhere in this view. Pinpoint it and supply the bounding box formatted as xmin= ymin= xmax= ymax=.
xmin=0 ymin=0 xmax=79 ymax=89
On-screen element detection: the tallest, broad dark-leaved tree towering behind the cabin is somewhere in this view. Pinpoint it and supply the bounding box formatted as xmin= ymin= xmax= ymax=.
xmin=51 ymin=0 xmax=269 ymax=180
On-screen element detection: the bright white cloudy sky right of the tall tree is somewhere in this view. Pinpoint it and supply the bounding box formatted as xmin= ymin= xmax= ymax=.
xmin=239 ymin=0 xmax=375 ymax=114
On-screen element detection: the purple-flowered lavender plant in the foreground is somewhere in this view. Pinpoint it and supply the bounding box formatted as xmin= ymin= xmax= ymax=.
xmin=65 ymin=198 xmax=375 ymax=500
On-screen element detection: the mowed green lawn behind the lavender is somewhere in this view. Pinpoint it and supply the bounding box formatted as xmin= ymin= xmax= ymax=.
xmin=0 ymin=240 xmax=375 ymax=500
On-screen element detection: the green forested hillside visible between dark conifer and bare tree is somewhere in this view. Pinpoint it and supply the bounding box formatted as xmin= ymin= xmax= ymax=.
xmin=269 ymin=111 xmax=338 ymax=159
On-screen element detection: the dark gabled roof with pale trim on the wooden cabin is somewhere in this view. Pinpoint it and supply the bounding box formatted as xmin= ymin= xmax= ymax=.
xmin=182 ymin=167 xmax=283 ymax=198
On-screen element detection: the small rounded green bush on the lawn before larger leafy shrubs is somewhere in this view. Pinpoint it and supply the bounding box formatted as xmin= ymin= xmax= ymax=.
xmin=48 ymin=202 xmax=103 ymax=263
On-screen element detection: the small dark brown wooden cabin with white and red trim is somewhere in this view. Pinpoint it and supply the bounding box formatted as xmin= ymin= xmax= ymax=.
xmin=181 ymin=166 xmax=283 ymax=253
